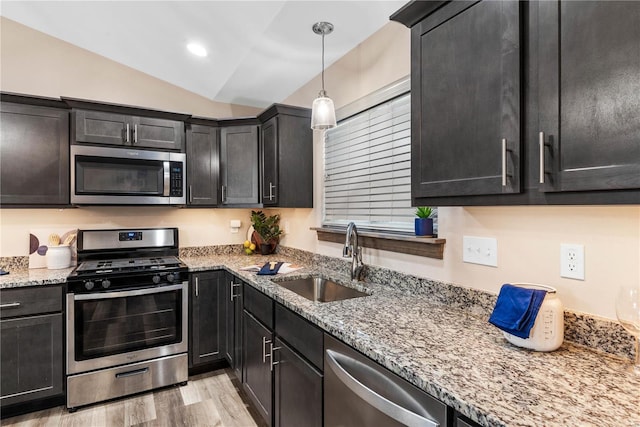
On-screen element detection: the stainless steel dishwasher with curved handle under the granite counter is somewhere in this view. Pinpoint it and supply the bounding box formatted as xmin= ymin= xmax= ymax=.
xmin=324 ymin=334 xmax=447 ymax=427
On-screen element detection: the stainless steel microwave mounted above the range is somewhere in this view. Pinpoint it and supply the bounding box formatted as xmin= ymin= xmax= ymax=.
xmin=71 ymin=145 xmax=186 ymax=205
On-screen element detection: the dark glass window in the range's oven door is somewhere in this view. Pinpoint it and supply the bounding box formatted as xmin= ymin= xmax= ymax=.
xmin=75 ymin=290 xmax=182 ymax=361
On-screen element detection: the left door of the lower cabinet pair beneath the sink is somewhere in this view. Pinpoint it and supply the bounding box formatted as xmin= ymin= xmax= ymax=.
xmin=242 ymin=311 xmax=273 ymax=425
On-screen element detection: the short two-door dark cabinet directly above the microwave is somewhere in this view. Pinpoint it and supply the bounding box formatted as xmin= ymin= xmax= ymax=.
xmin=63 ymin=98 xmax=190 ymax=152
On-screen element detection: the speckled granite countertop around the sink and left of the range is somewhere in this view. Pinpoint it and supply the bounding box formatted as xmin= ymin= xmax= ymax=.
xmin=0 ymin=255 xmax=640 ymax=427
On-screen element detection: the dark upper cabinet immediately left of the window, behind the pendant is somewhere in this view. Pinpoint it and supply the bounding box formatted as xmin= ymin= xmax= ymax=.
xmin=258 ymin=104 xmax=313 ymax=208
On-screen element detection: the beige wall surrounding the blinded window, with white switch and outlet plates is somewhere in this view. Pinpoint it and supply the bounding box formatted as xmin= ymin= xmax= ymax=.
xmin=283 ymin=22 xmax=640 ymax=319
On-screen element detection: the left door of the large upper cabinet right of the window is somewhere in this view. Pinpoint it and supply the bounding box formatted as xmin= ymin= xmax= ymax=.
xmin=411 ymin=1 xmax=521 ymax=198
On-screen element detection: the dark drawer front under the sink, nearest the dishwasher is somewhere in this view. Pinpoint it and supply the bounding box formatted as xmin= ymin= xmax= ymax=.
xmin=276 ymin=304 xmax=323 ymax=370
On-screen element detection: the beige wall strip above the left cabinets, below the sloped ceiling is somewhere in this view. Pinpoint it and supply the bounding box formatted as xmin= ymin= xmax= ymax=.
xmin=0 ymin=17 xmax=260 ymax=118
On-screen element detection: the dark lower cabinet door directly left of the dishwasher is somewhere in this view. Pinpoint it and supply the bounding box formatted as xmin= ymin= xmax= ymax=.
xmin=273 ymin=339 xmax=323 ymax=427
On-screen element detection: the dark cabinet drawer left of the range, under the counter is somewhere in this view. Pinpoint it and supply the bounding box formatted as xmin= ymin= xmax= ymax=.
xmin=0 ymin=286 xmax=62 ymax=319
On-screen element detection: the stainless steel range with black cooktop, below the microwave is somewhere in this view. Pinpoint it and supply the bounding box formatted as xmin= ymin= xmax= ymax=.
xmin=67 ymin=228 xmax=188 ymax=410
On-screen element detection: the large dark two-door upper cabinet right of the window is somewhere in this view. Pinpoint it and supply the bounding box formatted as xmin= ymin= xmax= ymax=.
xmin=391 ymin=0 xmax=640 ymax=206
